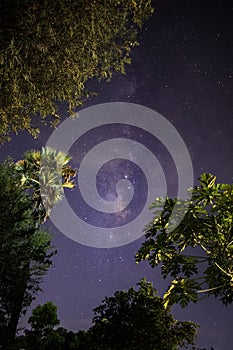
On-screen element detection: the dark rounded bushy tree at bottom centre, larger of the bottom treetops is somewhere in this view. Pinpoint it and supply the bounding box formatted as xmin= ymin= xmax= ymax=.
xmin=84 ymin=279 xmax=197 ymax=350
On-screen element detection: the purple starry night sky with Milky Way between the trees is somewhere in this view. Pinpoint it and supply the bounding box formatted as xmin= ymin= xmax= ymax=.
xmin=0 ymin=0 xmax=233 ymax=350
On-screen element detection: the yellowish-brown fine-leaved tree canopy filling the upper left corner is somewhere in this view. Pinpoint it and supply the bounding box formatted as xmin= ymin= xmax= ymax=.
xmin=0 ymin=0 xmax=153 ymax=141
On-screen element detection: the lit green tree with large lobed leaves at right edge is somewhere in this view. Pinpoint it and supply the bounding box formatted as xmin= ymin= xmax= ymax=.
xmin=136 ymin=174 xmax=233 ymax=306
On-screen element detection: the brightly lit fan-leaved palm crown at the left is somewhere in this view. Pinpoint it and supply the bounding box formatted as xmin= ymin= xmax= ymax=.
xmin=15 ymin=147 xmax=76 ymax=223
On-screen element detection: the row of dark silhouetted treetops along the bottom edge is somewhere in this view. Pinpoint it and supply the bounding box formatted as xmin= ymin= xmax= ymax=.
xmin=19 ymin=279 xmax=197 ymax=350
